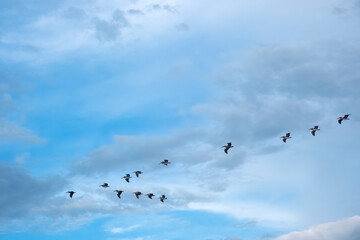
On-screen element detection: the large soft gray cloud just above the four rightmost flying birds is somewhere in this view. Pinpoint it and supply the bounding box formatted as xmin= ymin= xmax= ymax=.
xmin=192 ymin=42 xmax=360 ymax=146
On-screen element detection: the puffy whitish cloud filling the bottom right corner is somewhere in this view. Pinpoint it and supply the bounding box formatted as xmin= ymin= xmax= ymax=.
xmin=276 ymin=216 xmax=360 ymax=240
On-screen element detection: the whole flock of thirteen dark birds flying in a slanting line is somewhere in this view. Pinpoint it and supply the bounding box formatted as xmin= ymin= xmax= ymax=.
xmin=66 ymin=114 xmax=350 ymax=202
